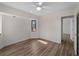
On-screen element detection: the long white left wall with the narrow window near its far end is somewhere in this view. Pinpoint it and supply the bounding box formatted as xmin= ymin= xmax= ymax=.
xmin=0 ymin=3 xmax=39 ymax=47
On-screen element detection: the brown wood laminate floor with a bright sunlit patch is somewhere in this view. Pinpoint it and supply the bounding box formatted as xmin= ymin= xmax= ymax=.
xmin=0 ymin=38 xmax=74 ymax=56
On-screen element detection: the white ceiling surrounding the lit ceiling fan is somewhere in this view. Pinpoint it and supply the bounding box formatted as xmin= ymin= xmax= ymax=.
xmin=2 ymin=2 xmax=78 ymax=15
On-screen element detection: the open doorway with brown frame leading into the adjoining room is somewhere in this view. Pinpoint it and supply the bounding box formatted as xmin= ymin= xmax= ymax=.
xmin=61 ymin=15 xmax=75 ymax=45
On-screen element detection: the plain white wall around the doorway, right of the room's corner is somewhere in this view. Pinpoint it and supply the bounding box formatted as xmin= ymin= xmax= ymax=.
xmin=39 ymin=10 xmax=74 ymax=43
